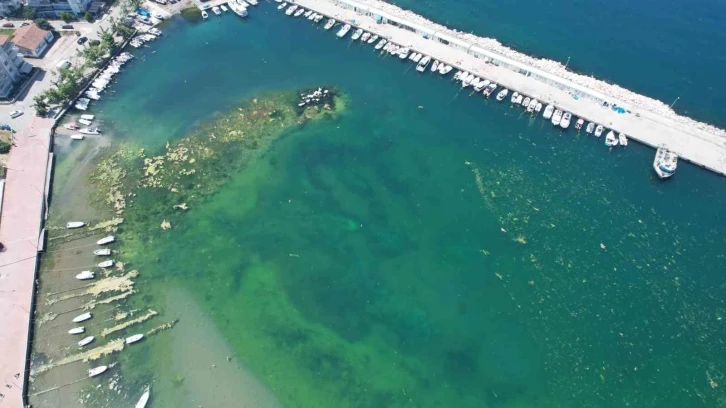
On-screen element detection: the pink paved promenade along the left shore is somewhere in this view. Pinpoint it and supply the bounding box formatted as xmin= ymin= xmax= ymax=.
xmin=0 ymin=118 xmax=53 ymax=408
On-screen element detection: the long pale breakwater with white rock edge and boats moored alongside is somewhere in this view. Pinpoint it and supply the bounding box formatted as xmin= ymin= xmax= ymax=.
xmin=288 ymin=0 xmax=726 ymax=175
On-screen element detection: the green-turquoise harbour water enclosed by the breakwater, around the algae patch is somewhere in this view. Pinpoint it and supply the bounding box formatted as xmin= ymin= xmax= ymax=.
xmin=44 ymin=5 xmax=726 ymax=407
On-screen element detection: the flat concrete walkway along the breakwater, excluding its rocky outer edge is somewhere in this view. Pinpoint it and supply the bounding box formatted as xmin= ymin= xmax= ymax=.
xmin=295 ymin=0 xmax=726 ymax=175
